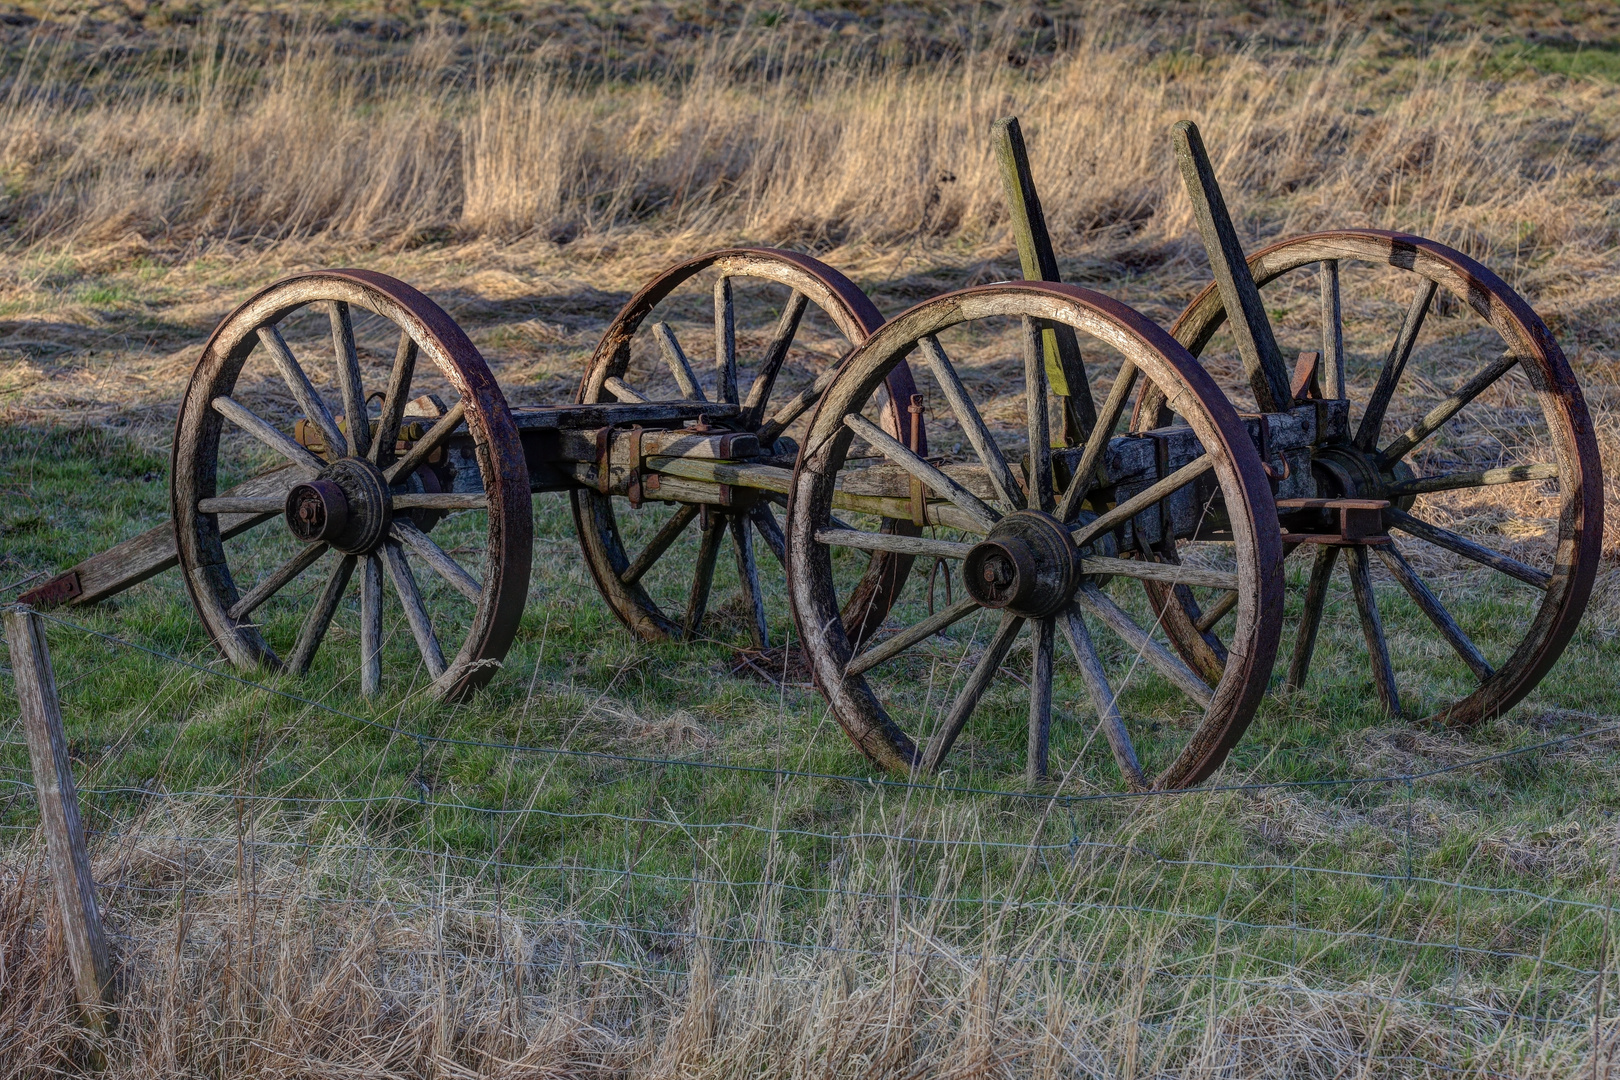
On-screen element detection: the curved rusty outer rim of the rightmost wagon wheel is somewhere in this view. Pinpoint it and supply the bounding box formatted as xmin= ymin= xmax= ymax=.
xmin=1171 ymin=228 xmax=1604 ymax=727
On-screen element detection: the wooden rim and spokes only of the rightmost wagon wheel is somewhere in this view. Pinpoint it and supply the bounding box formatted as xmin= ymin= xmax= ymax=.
xmin=1159 ymin=228 xmax=1604 ymax=727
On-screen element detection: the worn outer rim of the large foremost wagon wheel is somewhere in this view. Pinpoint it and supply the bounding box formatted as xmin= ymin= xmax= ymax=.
xmin=787 ymin=282 xmax=1283 ymax=789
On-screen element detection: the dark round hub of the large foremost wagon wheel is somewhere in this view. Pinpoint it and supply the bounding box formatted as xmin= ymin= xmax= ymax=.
xmin=962 ymin=510 xmax=1081 ymax=619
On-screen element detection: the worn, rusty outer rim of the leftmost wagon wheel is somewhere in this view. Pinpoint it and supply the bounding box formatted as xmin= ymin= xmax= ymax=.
xmin=170 ymin=269 xmax=533 ymax=699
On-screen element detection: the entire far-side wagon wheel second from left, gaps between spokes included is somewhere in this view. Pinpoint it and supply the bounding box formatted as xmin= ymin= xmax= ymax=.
xmin=572 ymin=248 xmax=927 ymax=649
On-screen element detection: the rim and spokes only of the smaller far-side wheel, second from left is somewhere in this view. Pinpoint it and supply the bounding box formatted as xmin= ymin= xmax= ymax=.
xmin=572 ymin=248 xmax=927 ymax=648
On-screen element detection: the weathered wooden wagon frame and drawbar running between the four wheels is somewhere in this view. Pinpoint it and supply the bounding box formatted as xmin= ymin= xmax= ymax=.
xmin=18 ymin=393 xmax=1346 ymax=607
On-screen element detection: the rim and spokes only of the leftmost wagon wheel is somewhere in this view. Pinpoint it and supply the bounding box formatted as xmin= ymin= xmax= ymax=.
xmin=170 ymin=270 xmax=533 ymax=699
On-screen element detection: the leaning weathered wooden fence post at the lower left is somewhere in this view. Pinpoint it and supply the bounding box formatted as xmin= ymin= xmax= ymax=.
xmin=5 ymin=607 xmax=112 ymax=1031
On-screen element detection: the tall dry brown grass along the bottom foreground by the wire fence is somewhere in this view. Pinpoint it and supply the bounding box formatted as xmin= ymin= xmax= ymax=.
xmin=0 ymin=797 xmax=1591 ymax=1080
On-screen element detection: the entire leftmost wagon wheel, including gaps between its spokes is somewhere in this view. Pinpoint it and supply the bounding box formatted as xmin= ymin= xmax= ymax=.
xmin=170 ymin=270 xmax=533 ymax=698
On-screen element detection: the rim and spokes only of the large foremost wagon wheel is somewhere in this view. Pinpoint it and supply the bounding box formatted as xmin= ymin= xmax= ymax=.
xmin=787 ymin=282 xmax=1283 ymax=789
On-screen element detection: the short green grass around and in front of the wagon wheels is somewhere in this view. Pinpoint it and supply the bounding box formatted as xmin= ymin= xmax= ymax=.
xmin=0 ymin=427 xmax=1620 ymax=1049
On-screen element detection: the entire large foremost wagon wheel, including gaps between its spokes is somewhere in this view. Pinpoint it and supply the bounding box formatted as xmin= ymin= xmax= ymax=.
xmin=787 ymin=282 xmax=1283 ymax=789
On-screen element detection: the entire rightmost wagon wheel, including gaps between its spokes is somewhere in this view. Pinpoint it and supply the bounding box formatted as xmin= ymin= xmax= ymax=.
xmin=1146 ymin=230 xmax=1604 ymax=725
